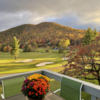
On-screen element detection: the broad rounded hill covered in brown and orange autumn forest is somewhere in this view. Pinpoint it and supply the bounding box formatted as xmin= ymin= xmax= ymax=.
xmin=0 ymin=22 xmax=84 ymax=46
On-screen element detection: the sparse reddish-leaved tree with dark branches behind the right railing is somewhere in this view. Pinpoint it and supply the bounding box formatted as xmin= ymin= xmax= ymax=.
xmin=63 ymin=37 xmax=100 ymax=85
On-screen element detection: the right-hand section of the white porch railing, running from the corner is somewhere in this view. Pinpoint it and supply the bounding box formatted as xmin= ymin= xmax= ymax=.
xmin=43 ymin=70 xmax=100 ymax=98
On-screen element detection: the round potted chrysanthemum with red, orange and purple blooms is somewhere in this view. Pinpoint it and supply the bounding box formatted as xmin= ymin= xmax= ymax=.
xmin=21 ymin=74 xmax=50 ymax=100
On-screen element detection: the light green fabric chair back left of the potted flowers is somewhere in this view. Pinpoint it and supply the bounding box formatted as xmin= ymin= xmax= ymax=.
xmin=3 ymin=77 xmax=25 ymax=98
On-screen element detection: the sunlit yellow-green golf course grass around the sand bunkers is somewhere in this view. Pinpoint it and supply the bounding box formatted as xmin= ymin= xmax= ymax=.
xmin=0 ymin=48 xmax=66 ymax=76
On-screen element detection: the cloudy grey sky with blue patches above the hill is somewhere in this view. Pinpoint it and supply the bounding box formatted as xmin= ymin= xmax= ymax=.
xmin=0 ymin=0 xmax=100 ymax=31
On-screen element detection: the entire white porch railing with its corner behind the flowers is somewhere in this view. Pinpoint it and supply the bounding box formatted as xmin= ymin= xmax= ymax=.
xmin=0 ymin=70 xmax=100 ymax=100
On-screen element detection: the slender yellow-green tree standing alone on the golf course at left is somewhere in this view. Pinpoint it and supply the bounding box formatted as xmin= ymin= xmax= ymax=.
xmin=11 ymin=37 xmax=20 ymax=59
